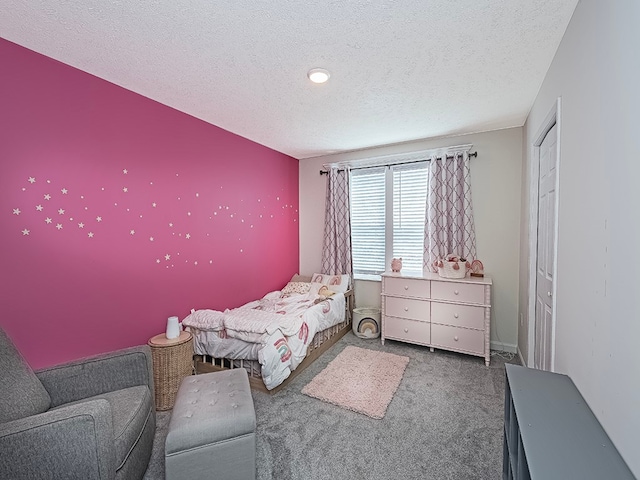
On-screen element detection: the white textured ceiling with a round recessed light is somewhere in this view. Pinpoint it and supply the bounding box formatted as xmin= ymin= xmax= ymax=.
xmin=0 ymin=0 xmax=578 ymax=158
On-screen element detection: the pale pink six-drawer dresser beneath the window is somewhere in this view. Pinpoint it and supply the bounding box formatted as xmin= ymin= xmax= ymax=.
xmin=381 ymin=272 xmax=491 ymax=365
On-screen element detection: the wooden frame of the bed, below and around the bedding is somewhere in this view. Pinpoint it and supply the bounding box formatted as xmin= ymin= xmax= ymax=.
xmin=193 ymin=290 xmax=354 ymax=393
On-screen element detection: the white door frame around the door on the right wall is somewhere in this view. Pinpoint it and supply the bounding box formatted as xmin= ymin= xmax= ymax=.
xmin=527 ymin=97 xmax=562 ymax=372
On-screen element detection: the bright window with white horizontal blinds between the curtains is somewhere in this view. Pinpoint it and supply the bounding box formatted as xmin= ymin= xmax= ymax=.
xmin=350 ymin=161 xmax=429 ymax=279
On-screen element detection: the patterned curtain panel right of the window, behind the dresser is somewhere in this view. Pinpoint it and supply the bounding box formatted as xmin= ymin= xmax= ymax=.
xmin=424 ymin=152 xmax=476 ymax=272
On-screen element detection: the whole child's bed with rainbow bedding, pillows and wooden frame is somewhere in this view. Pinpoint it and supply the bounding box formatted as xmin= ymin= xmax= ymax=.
xmin=182 ymin=274 xmax=354 ymax=393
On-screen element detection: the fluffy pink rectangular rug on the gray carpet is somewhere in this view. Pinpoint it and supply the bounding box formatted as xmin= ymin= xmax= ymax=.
xmin=302 ymin=346 xmax=409 ymax=418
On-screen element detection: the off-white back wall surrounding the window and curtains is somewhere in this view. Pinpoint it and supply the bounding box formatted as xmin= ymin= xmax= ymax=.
xmin=300 ymin=127 xmax=523 ymax=352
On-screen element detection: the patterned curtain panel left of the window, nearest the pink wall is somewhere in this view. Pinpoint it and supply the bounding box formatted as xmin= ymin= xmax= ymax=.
xmin=322 ymin=167 xmax=353 ymax=278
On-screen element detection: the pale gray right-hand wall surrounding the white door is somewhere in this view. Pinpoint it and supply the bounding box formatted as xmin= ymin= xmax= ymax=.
xmin=520 ymin=0 xmax=640 ymax=477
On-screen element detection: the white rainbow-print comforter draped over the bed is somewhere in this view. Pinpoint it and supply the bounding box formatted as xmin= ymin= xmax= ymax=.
xmin=182 ymin=291 xmax=345 ymax=390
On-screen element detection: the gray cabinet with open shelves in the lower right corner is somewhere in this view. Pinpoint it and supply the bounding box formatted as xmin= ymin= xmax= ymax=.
xmin=502 ymin=364 xmax=635 ymax=480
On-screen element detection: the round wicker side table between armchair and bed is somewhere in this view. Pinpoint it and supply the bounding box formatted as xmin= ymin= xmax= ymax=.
xmin=148 ymin=332 xmax=193 ymax=410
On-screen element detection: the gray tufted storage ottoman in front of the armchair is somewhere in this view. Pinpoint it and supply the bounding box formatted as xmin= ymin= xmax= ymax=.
xmin=164 ymin=368 xmax=256 ymax=480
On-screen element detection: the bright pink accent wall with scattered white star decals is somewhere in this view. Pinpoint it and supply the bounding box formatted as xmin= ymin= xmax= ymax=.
xmin=0 ymin=39 xmax=299 ymax=368
